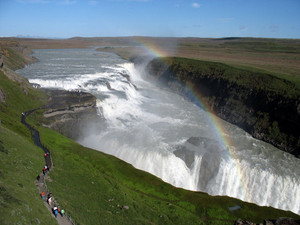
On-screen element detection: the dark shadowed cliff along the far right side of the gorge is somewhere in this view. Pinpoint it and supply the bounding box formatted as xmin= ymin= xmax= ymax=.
xmin=146 ymin=58 xmax=300 ymax=157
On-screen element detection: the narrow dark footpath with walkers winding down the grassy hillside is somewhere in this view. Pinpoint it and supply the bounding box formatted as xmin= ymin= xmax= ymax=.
xmin=21 ymin=110 xmax=75 ymax=225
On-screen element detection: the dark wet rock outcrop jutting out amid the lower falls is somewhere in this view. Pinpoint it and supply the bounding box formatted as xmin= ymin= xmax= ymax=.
xmin=173 ymin=137 xmax=222 ymax=191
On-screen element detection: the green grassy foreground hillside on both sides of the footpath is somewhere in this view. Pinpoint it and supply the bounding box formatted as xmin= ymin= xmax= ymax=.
xmin=0 ymin=46 xmax=300 ymax=225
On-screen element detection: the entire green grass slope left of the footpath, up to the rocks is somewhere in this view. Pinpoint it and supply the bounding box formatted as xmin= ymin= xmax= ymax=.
xmin=0 ymin=71 xmax=57 ymax=224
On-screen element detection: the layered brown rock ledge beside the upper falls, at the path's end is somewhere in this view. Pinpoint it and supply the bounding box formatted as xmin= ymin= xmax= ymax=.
xmin=43 ymin=89 xmax=101 ymax=140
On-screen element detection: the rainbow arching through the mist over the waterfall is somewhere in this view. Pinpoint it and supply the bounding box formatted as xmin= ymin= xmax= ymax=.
xmin=134 ymin=40 xmax=249 ymax=200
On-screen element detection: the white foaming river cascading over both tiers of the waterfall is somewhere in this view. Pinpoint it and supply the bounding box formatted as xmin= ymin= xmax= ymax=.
xmin=19 ymin=50 xmax=300 ymax=214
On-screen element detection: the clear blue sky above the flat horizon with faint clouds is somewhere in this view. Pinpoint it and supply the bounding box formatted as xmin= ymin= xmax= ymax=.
xmin=0 ymin=0 xmax=300 ymax=38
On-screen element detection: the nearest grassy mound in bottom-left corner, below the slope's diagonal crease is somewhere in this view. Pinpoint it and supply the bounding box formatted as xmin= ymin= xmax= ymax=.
xmin=0 ymin=125 xmax=57 ymax=225
